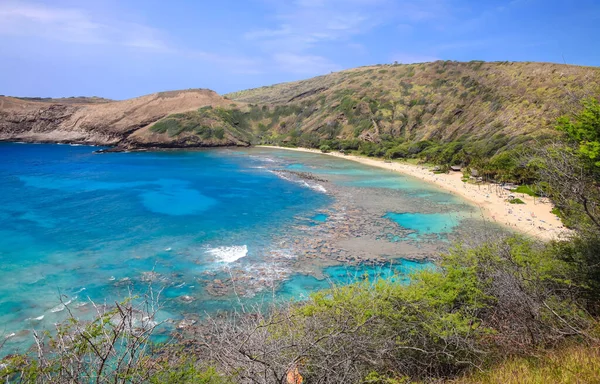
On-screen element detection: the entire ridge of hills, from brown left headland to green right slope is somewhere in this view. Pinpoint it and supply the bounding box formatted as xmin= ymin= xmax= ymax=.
xmin=0 ymin=61 xmax=600 ymax=155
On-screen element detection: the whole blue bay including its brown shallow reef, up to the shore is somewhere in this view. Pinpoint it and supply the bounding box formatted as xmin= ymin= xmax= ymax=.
xmin=0 ymin=143 xmax=476 ymax=349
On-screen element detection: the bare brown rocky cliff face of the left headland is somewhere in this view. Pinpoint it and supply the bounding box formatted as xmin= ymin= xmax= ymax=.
xmin=0 ymin=89 xmax=247 ymax=148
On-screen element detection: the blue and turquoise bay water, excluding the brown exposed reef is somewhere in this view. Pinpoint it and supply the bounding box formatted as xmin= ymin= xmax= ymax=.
xmin=0 ymin=143 xmax=474 ymax=347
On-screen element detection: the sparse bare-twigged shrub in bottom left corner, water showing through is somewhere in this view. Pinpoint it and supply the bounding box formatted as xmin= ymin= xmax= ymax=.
xmin=0 ymin=290 xmax=233 ymax=384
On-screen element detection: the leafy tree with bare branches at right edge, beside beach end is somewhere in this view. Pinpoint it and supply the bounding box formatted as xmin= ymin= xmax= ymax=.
xmin=532 ymin=99 xmax=600 ymax=313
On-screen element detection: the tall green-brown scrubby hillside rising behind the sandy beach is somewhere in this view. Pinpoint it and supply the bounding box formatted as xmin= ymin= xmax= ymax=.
xmin=225 ymin=61 xmax=600 ymax=161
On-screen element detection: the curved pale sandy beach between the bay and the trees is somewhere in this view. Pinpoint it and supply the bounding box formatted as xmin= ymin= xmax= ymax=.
xmin=261 ymin=146 xmax=570 ymax=240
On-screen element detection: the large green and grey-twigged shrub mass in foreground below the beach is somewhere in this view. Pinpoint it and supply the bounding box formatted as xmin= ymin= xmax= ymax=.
xmin=190 ymin=237 xmax=594 ymax=383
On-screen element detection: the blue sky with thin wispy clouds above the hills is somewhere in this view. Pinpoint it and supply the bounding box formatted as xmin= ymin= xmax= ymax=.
xmin=0 ymin=0 xmax=600 ymax=99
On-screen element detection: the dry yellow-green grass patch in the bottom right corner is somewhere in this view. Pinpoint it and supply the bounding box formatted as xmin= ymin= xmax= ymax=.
xmin=447 ymin=345 xmax=600 ymax=384
